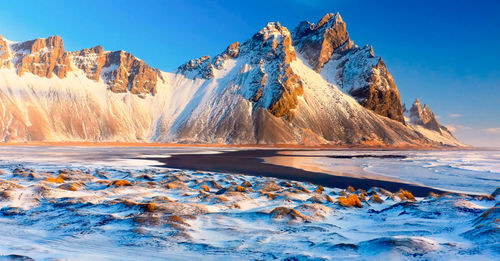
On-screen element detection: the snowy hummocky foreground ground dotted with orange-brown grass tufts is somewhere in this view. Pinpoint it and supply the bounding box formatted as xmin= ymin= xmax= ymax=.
xmin=0 ymin=147 xmax=500 ymax=260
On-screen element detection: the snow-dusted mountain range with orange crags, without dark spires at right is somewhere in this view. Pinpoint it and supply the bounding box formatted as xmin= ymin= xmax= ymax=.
xmin=0 ymin=14 xmax=460 ymax=146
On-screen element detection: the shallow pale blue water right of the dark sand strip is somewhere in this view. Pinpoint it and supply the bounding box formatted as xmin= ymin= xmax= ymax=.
xmin=295 ymin=150 xmax=500 ymax=194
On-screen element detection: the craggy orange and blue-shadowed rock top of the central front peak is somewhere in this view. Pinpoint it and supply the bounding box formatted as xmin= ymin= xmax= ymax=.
xmin=178 ymin=23 xmax=303 ymax=120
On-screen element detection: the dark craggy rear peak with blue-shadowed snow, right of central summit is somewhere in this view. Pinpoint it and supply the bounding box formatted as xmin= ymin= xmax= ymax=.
xmin=293 ymin=13 xmax=404 ymax=122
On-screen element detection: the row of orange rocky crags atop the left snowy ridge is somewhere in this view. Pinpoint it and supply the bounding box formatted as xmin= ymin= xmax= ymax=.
xmin=0 ymin=36 xmax=159 ymax=94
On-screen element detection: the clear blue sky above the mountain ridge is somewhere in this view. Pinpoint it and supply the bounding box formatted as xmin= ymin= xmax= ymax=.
xmin=0 ymin=0 xmax=500 ymax=146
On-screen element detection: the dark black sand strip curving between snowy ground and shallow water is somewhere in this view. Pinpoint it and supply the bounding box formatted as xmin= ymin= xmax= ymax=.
xmin=151 ymin=149 xmax=445 ymax=197
